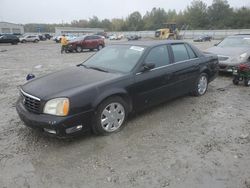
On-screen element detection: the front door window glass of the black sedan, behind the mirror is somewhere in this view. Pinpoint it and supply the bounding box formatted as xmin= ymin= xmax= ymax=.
xmin=145 ymin=45 xmax=170 ymax=67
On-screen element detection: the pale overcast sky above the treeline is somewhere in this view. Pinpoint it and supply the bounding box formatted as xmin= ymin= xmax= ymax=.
xmin=0 ymin=0 xmax=250 ymax=24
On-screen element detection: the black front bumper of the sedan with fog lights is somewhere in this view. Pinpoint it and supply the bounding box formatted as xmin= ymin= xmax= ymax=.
xmin=16 ymin=99 xmax=93 ymax=137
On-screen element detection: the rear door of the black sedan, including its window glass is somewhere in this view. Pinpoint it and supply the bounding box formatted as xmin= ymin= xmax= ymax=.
xmin=170 ymin=43 xmax=199 ymax=96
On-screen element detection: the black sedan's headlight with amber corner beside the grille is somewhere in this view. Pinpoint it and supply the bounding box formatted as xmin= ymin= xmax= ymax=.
xmin=43 ymin=98 xmax=69 ymax=116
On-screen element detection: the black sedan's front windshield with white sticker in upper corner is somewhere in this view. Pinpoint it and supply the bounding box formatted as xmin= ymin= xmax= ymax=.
xmin=83 ymin=45 xmax=144 ymax=73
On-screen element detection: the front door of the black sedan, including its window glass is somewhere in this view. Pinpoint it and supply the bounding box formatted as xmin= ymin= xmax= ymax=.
xmin=134 ymin=45 xmax=172 ymax=108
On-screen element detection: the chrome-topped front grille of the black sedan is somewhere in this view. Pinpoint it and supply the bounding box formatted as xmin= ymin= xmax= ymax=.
xmin=21 ymin=90 xmax=41 ymax=114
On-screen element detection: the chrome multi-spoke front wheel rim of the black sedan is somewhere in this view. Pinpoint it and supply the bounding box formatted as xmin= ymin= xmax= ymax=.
xmin=101 ymin=103 xmax=125 ymax=132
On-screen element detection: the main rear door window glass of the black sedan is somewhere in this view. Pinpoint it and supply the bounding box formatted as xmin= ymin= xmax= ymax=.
xmin=171 ymin=44 xmax=189 ymax=62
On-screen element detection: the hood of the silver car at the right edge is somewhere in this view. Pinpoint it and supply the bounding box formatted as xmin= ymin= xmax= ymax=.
xmin=205 ymin=46 xmax=250 ymax=57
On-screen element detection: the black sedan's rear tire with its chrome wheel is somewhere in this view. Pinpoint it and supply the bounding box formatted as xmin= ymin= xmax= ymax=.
xmin=192 ymin=73 xmax=208 ymax=96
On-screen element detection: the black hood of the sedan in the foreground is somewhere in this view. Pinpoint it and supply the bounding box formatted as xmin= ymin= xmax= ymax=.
xmin=22 ymin=66 xmax=122 ymax=99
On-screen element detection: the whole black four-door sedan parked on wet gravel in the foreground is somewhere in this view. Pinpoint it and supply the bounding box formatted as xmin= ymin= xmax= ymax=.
xmin=16 ymin=41 xmax=218 ymax=136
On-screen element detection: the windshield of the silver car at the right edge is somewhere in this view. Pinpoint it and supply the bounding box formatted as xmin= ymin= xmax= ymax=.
xmin=218 ymin=36 xmax=250 ymax=48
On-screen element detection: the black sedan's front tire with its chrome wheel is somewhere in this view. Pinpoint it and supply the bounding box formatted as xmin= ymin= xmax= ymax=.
xmin=92 ymin=96 xmax=128 ymax=135
